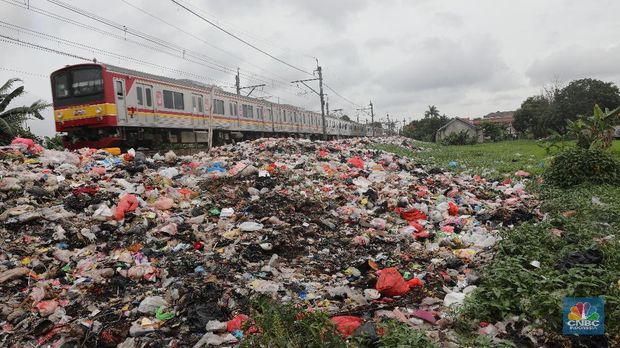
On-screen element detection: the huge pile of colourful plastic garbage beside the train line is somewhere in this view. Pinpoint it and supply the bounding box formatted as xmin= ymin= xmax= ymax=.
xmin=0 ymin=137 xmax=539 ymax=347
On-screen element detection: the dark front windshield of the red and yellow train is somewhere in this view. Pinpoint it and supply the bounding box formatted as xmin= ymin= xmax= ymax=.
xmin=53 ymin=67 xmax=104 ymax=106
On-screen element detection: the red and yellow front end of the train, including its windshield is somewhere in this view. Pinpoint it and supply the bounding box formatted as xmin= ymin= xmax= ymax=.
xmin=51 ymin=64 xmax=120 ymax=149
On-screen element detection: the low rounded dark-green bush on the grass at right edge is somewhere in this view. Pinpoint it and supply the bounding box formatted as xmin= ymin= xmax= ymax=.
xmin=544 ymin=148 xmax=620 ymax=187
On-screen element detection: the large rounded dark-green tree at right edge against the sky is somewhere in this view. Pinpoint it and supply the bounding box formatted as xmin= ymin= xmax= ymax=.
xmin=548 ymin=78 xmax=620 ymax=133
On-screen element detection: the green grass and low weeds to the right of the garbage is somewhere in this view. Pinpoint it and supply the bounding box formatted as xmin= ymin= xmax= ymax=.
xmin=372 ymin=140 xmax=620 ymax=347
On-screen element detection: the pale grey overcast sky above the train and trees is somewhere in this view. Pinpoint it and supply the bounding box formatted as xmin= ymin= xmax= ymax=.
xmin=0 ymin=0 xmax=620 ymax=135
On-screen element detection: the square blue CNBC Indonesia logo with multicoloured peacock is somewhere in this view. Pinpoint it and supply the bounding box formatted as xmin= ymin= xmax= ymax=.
xmin=563 ymin=297 xmax=605 ymax=335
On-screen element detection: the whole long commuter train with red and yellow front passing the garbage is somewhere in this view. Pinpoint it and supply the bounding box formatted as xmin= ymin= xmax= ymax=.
xmin=51 ymin=63 xmax=383 ymax=149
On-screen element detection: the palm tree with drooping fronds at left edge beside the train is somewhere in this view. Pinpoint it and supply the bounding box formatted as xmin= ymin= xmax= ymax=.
xmin=0 ymin=78 xmax=50 ymax=144
